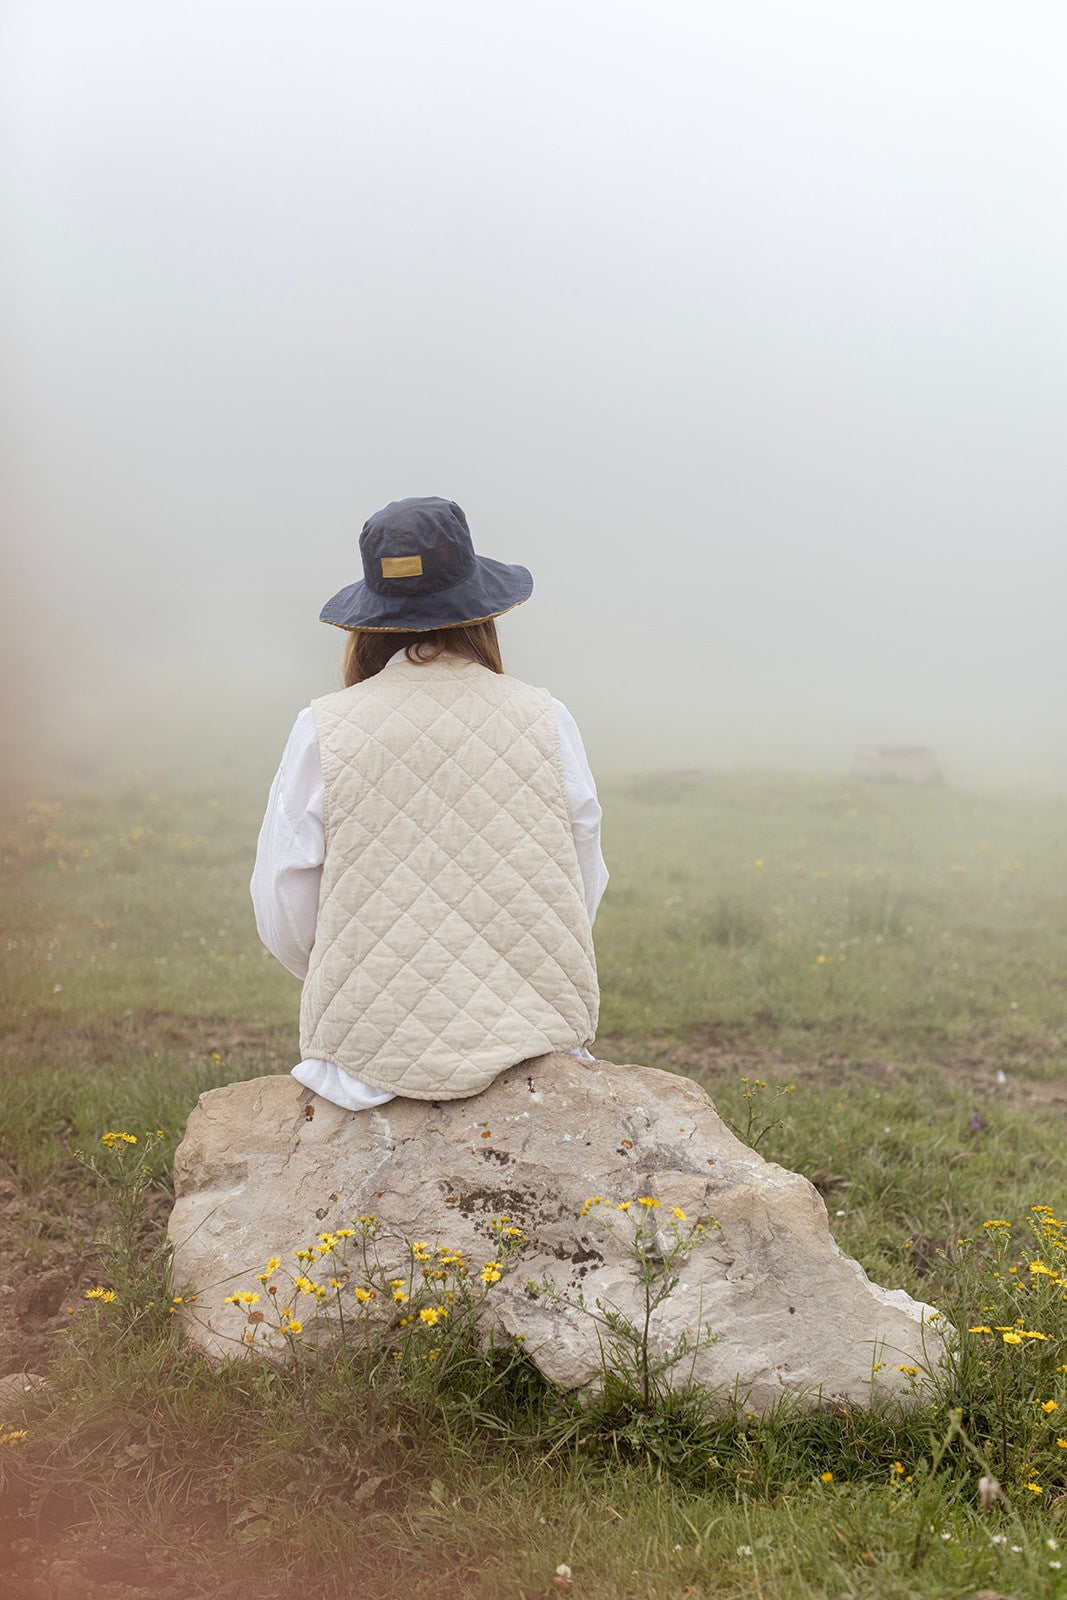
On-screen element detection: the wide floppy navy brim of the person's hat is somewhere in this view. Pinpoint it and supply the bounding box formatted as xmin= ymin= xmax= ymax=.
xmin=318 ymin=555 xmax=533 ymax=634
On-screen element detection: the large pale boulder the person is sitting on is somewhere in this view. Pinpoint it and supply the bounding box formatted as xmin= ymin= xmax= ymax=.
xmin=170 ymin=1054 xmax=941 ymax=1411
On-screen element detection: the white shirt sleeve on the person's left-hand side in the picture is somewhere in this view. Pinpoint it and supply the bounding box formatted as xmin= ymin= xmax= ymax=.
xmin=251 ymin=706 xmax=326 ymax=978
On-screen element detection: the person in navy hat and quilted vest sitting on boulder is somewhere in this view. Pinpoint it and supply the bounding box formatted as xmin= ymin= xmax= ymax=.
xmin=251 ymin=498 xmax=608 ymax=1110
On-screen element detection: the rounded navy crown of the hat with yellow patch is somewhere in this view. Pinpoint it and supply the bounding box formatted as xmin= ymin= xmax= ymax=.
xmin=360 ymin=494 xmax=475 ymax=595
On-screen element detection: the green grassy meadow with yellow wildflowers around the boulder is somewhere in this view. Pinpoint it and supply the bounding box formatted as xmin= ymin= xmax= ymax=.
xmin=0 ymin=773 xmax=1067 ymax=1600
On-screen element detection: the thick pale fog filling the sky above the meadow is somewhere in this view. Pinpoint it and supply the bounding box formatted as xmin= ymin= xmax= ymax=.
xmin=0 ymin=0 xmax=1067 ymax=784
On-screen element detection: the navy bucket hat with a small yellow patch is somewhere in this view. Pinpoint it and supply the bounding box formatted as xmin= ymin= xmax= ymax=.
xmin=318 ymin=494 xmax=533 ymax=634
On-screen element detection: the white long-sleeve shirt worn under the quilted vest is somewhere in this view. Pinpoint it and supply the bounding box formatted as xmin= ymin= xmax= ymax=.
xmin=244 ymin=651 xmax=608 ymax=1110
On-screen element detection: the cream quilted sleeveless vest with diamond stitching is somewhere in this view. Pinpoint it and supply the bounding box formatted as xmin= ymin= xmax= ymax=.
xmin=301 ymin=658 xmax=600 ymax=1099
